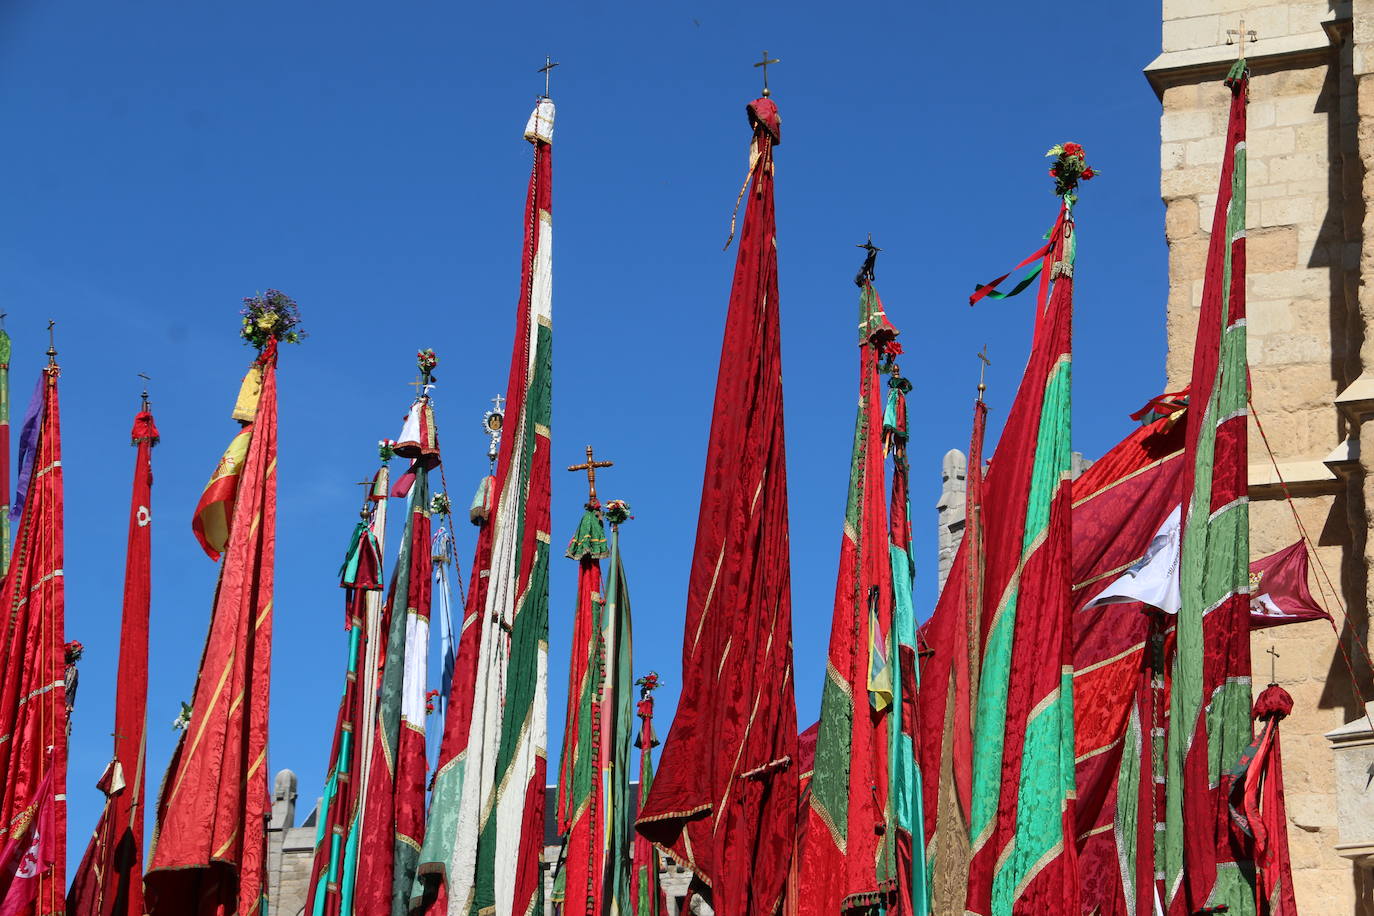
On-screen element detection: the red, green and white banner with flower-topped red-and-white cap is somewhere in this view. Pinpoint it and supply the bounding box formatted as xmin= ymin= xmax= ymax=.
xmin=354 ymin=362 xmax=438 ymax=916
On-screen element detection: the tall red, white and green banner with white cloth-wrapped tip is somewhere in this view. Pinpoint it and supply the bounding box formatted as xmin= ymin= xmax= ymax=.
xmin=411 ymin=99 xmax=554 ymax=916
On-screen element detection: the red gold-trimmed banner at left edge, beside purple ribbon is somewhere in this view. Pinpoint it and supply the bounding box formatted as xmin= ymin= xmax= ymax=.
xmin=0 ymin=365 xmax=67 ymax=916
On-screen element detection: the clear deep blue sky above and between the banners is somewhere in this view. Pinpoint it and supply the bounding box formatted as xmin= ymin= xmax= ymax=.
xmin=0 ymin=0 xmax=1170 ymax=864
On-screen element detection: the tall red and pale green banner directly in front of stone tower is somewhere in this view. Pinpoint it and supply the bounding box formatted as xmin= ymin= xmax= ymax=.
xmin=1161 ymin=60 xmax=1254 ymax=916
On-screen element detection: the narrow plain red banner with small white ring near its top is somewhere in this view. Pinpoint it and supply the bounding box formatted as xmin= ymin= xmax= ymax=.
xmin=67 ymin=409 xmax=158 ymax=916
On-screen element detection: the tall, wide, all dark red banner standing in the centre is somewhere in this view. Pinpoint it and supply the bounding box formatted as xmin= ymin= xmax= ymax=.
xmin=636 ymin=99 xmax=797 ymax=916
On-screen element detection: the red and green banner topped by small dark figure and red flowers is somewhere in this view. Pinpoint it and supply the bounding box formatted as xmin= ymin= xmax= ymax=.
xmin=797 ymin=254 xmax=900 ymax=916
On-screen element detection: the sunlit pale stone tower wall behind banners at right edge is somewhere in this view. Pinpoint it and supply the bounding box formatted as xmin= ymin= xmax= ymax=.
xmin=1145 ymin=0 xmax=1374 ymax=915
